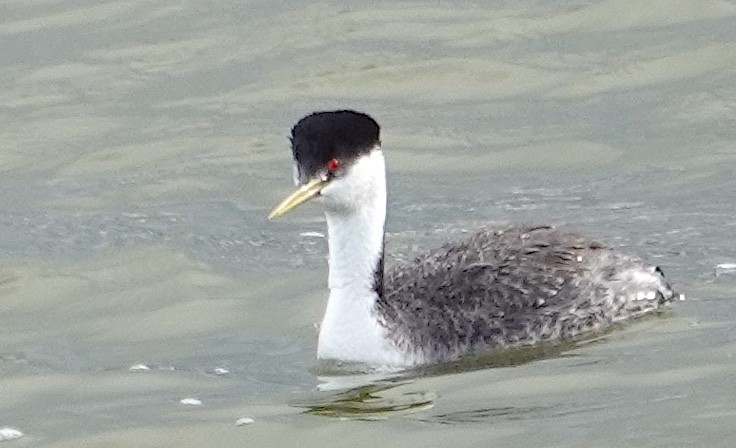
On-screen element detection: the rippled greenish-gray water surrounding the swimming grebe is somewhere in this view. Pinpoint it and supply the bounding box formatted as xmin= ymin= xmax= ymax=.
xmin=0 ymin=0 xmax=736 ymax=447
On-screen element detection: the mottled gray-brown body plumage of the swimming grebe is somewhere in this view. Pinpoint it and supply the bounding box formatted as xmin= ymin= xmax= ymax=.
xmin=376 ymin=227 xmax=675 ymax=362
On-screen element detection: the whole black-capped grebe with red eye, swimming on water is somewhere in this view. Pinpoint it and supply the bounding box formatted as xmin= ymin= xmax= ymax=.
xmin=268 ymin=109 xmax=680 ymax=369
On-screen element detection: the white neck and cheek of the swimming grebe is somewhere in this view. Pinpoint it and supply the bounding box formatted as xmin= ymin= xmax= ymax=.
xmin=317 ymin=149 xmax=405 ymax=365
